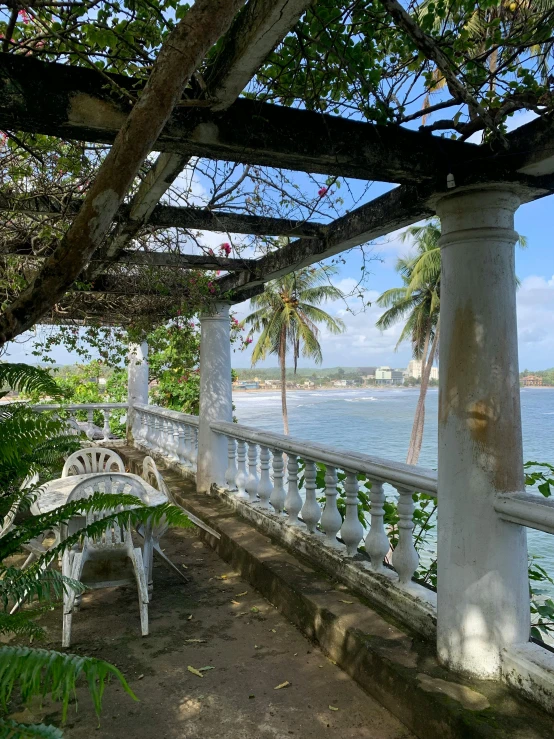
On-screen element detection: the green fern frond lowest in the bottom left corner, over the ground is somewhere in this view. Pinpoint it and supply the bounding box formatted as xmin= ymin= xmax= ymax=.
xmin=0 ymin=646 xmax=138 ymax=721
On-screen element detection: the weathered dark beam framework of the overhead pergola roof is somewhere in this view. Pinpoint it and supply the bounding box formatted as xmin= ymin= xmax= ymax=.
xmin=0 ymin=0 xmax=554 ymax=338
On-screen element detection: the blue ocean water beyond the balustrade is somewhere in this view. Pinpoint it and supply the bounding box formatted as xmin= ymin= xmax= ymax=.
xmin=233 ymin=388 xmax=554 ymax=580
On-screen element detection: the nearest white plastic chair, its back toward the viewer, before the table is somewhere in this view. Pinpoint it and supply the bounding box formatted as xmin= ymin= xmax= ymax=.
xmin=62 ymin=473 xmax=149 ymax=647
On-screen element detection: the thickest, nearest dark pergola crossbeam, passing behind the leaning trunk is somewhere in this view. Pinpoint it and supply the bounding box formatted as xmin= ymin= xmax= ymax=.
xmin=0 ymin=54 xmax=476 ymax=183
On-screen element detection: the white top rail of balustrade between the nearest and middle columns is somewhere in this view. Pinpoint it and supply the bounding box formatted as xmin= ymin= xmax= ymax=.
xmin=210 ymin=421 xmax=437 ymax=496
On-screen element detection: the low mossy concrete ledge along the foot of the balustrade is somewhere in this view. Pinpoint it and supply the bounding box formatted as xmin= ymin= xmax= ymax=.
xmin=119 ymin=449 xmax=553 ymax=739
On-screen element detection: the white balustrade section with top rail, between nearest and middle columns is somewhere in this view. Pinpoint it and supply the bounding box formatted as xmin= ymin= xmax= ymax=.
xmin=211 ymin=421 xmax=437 ymax=587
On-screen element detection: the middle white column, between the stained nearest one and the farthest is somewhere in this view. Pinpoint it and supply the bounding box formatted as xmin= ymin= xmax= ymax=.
xmin=196 ymin=303 xmax=233 ymax=493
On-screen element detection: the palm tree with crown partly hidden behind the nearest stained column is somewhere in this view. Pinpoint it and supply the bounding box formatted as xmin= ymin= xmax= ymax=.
xmin=376 ymin=220 xmax=441 ymax=464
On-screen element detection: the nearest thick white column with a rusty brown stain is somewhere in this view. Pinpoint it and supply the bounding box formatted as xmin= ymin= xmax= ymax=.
xmin=437 ymin=186 xmax=529 ymax=678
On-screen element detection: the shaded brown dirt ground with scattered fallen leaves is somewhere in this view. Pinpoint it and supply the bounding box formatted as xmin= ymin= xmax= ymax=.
xmin=6 ymin=530 xmax=413 ymax=739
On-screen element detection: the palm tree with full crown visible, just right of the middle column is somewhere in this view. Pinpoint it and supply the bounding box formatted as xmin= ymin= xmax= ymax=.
xmin=245 ymin=267 xmax=346 ymax=434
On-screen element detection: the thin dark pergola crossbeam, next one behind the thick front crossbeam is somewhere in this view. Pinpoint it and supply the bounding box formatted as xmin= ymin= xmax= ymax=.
xmin=0 ymin=193 xmax=325 ymax=238
